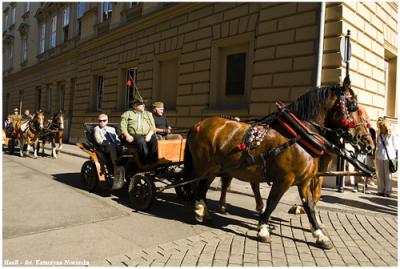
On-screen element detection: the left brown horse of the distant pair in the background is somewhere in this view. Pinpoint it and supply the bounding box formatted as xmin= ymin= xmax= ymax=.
xmin=16 ymin=111 xmax=44 ymax=159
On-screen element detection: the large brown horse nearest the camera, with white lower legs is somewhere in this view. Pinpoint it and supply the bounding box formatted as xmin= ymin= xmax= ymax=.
xmin=184 ymin=87 xmax=360 ymax=249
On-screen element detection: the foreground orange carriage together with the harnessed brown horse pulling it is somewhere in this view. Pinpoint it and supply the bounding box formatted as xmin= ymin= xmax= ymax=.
xmin=78 ymin=80 xmax=374 ymax=249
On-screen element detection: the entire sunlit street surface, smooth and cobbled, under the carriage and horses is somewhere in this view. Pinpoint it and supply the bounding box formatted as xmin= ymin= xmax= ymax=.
xmin=3 ymin=145 xmax=398 ymax=266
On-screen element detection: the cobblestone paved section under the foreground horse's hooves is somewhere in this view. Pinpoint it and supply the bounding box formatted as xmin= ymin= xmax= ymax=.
xmin=96 ymin=210 xmax=397 ymax=266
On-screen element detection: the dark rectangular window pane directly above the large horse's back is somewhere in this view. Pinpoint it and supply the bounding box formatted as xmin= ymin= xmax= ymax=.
xmin=225 ymin=53 xmax=246 ymax=96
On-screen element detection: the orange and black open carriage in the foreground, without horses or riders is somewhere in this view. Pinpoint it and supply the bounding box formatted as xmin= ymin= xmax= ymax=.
xmin=77 ymin=123 xmax=192 ymax=210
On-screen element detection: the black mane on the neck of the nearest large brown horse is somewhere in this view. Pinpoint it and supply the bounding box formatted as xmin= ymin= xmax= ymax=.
xmin=288 ymin=86 xmax=340 ymax=120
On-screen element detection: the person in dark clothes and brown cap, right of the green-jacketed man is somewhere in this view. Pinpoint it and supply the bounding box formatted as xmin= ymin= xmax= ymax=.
xmin=153 ymin=102 xmax=182 ymax=140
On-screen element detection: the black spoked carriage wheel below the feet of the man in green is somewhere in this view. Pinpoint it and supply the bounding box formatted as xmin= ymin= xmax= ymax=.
xmin=128 ymin=173 xmax=156 ymax=210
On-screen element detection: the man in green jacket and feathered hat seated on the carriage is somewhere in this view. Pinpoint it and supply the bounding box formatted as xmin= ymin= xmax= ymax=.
xmin=121 ymin=89 xmax=158 ymax=165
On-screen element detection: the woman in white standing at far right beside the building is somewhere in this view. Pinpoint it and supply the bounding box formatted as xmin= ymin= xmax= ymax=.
xmin=376 ymin=118 xmax=398 ymax=197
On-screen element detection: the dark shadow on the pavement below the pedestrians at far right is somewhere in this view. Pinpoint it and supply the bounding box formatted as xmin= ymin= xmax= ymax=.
xmin=321 ymin=195 xmax=397 ymax=216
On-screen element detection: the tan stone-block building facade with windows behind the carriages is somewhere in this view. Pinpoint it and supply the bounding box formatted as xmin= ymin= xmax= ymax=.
xmin=3 ymin=2 xmax=398 ymax=142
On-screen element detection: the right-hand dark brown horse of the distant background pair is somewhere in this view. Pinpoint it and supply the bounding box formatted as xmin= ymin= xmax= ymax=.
xmin=42 ymin=110 xmax=64 ymax=159
